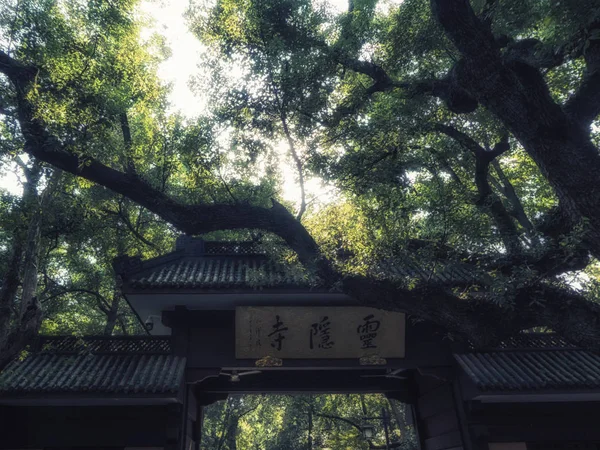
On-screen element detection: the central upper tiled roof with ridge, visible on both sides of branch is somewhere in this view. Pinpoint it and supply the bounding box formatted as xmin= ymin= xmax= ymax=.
xmin=114 ymin=236 xmax=485 ymax=289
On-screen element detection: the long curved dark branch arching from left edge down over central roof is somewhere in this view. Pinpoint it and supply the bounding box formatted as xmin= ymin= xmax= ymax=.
xmin=0 ymin=51 xmax=335 ymax=282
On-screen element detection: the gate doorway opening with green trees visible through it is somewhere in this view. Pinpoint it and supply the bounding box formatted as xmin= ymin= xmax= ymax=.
xmin=200 ymin=393 xmax=419 ymax=450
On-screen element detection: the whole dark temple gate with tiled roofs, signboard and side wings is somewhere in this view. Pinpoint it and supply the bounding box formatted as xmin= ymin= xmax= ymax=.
xmin=0 ymin=237 xmax=600 ymax=450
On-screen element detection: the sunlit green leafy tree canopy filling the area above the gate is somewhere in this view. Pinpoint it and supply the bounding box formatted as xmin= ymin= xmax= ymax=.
xmin=0 ymin=0 xmax=600 ymax=344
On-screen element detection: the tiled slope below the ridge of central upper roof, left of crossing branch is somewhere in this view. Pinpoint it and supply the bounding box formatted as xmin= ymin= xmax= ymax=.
xmin=129 ymin=256 xmax=306 ymax=289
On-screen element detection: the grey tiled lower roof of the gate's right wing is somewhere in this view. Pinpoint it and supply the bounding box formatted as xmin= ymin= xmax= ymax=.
xmin=455 ymin=348 xmax=600 ymax=392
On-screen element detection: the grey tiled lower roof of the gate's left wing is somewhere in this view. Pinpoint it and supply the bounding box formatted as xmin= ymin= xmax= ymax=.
xmin=0 ymin=353 xmax=185 ymax=398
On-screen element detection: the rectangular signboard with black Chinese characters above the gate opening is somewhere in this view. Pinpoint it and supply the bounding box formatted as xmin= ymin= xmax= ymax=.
xmin=235 ymin=306 xmax=405 ymax=359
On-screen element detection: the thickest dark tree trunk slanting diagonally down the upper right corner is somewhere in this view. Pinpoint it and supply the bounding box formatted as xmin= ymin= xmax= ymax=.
xmin=431 ymin=0 xmax=600 ymax=266
